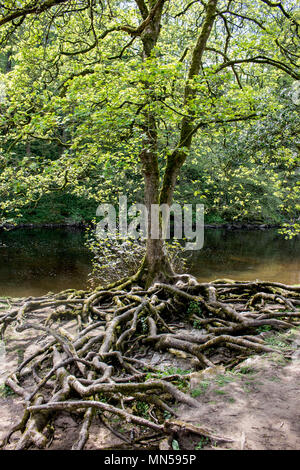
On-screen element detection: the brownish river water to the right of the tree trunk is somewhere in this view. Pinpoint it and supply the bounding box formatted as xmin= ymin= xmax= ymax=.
xmin=189 ymin=230 xmax=300 ymax=284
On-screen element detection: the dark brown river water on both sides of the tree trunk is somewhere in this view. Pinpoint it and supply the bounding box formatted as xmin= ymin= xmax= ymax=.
xmin=0 ymin=229 xmax=300 ymax=297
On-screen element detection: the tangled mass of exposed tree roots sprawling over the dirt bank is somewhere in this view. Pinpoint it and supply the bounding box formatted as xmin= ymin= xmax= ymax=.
xmin=0 ymin=275 xmax=300 ymax=449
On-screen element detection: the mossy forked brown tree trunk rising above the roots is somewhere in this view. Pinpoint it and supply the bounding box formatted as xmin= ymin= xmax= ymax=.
xmin=138 ymin=0 xmax=217 ymax=287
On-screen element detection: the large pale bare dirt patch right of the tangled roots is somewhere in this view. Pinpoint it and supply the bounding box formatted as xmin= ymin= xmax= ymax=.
xmin=180 ymin=331 xmax=300 ymax=450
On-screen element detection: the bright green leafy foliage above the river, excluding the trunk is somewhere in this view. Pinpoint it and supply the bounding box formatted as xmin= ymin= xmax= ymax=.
xmin=0 ymin=0 xmax=300 ymax=238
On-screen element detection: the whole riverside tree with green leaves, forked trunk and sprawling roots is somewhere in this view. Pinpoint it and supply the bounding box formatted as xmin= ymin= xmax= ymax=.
xmin=0 ymin=0 xmax=300 ymax=449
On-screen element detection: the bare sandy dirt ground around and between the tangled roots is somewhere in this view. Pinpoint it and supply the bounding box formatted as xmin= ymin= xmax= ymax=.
xmin=0 ymin=329 xmax=300 ymax=450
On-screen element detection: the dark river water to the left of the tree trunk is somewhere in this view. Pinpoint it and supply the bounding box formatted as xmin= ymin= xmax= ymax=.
xmin=0 ymin=229 xmax=91 ymax=296
